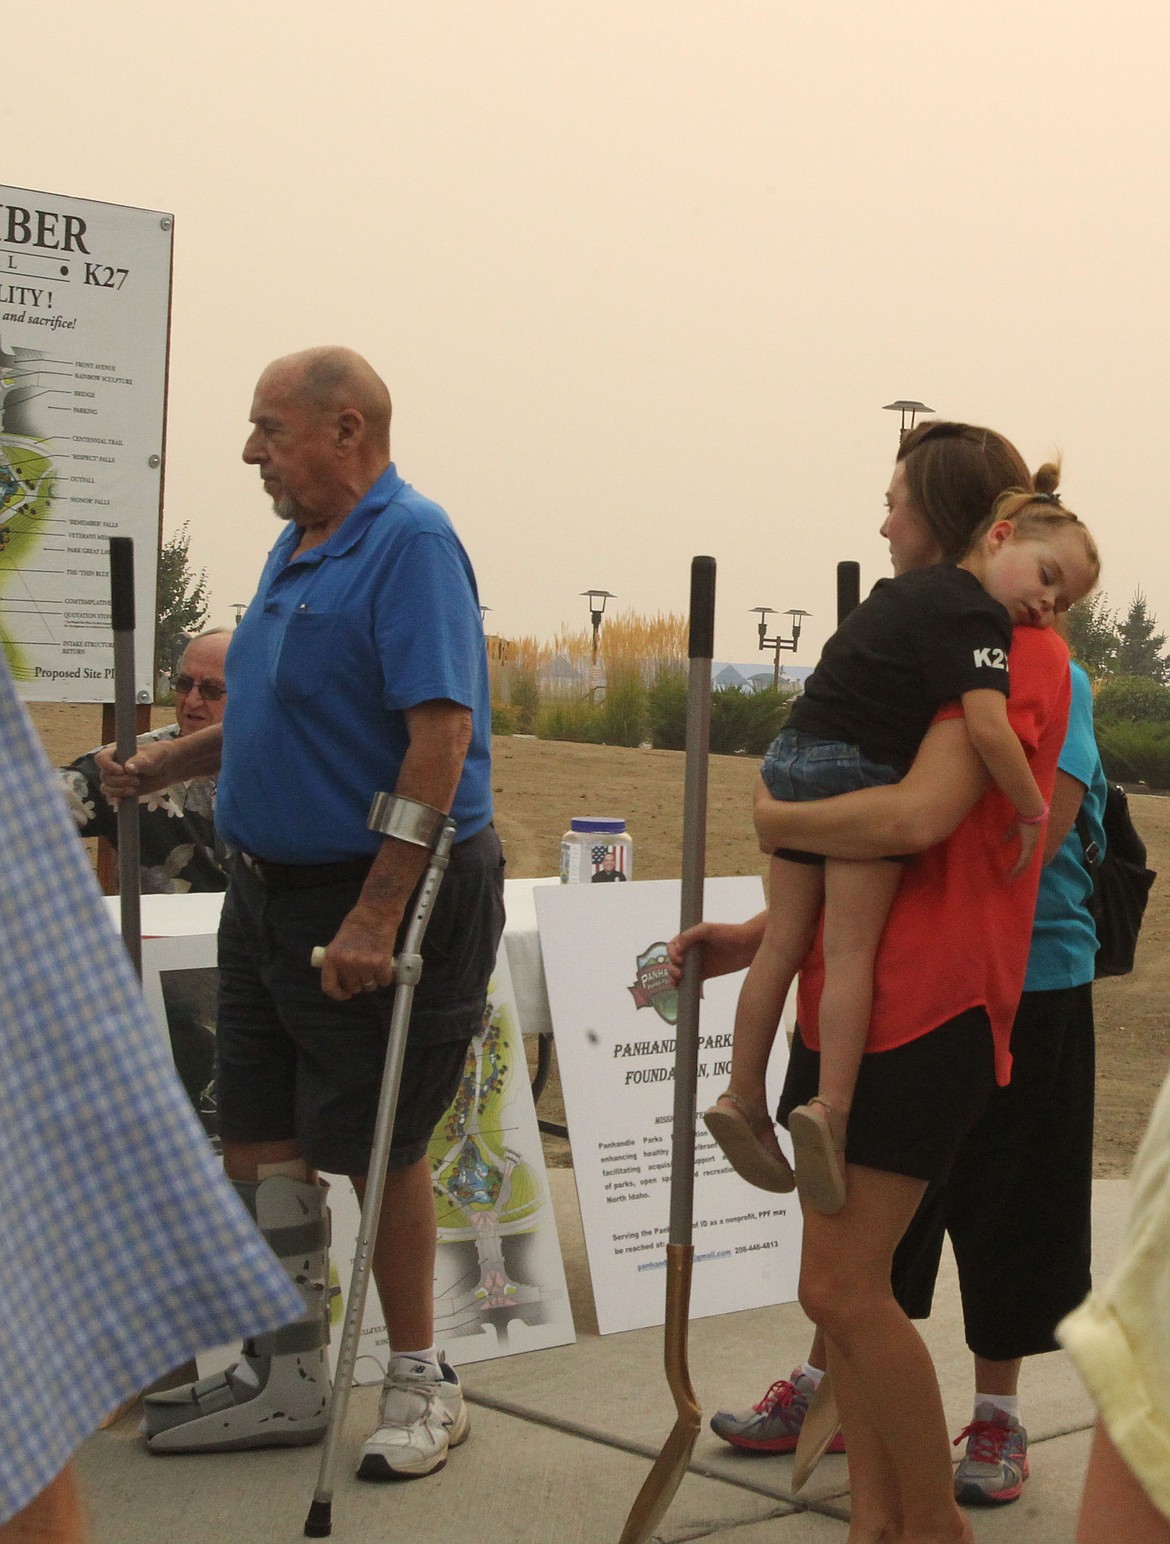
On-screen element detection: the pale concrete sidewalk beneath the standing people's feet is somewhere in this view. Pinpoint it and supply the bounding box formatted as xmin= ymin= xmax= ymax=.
xmin=79 ymin=1169 xmax=1128 ymax=1544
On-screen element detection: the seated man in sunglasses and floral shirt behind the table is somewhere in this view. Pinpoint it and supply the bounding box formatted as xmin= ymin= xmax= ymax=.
xmin=60 ymin=627 xmax=232 ymax=896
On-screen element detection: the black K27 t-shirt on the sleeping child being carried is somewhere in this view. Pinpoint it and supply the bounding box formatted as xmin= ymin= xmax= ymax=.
xmin=789 ymin=564 xmax=1011 ymax=772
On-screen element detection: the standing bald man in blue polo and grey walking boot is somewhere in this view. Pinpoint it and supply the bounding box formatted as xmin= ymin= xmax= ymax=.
xmin=107 ymin=349 xmax=503 ymax=1479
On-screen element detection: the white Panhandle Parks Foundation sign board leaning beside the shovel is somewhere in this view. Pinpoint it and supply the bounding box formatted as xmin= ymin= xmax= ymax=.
xmin=536 ymin=879 xmax=801 ymax=1334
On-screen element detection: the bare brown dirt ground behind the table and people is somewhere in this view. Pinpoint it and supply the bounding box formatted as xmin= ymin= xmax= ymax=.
xmin=32 ymin=704 xmax=1170 ymax=1175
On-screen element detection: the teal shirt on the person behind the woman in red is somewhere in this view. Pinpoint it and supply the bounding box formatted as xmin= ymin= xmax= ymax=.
xmin=1023 ymin=664 xmax=1105 ymax=991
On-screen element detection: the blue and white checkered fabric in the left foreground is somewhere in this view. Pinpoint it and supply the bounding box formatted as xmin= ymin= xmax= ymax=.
xmin=0 ymin=670 xmax=303 ymax=1521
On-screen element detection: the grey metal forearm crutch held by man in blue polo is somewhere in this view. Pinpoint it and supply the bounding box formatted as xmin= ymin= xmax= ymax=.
xmin=304 ymin=794 xmax=455 ymax=1539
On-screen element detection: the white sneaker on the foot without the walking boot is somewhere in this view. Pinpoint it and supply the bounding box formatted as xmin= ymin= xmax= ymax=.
xmin=358 ymin=1356 xmax=471 ymax=1479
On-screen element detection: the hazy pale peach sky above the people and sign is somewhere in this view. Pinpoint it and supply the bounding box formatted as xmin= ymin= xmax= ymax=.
xmin=11 ymin=0 xmax=1170 ymax=664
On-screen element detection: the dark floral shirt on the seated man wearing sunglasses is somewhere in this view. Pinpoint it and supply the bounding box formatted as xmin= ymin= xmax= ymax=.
xmin=59 ymin=724 xmax=227 ymax=896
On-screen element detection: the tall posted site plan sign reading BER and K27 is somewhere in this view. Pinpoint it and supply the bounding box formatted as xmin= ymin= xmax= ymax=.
xmin=0 ymin=187 xmax=173 ymax=703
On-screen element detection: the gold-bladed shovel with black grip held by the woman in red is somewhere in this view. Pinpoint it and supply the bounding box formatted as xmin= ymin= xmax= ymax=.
xmin=621 ymin=557 xmax=715 ymax=1544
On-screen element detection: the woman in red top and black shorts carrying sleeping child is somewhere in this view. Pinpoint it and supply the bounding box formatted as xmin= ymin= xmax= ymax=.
xmin=676 ymin=423 xmax=1096 ymax=1544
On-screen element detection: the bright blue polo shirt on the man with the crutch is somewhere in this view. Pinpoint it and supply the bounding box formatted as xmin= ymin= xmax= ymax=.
xmin=216 ymin=465 xmax=492 ymax=863
